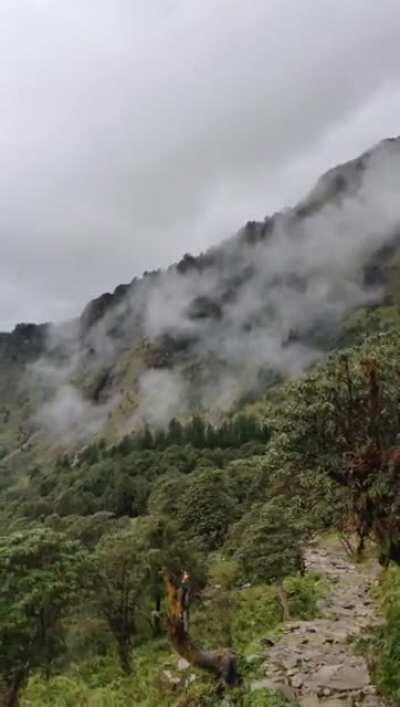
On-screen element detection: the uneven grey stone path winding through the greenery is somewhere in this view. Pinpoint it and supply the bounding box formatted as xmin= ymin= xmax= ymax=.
xmin=253 ymin=547 xmax=385 ymax=707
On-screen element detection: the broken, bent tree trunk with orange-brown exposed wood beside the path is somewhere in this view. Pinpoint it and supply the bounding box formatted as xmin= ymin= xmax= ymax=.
xmin=165 ymin=575 xmax=239 ymax=687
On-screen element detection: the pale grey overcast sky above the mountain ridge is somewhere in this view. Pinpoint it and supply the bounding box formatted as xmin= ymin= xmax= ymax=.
xmin=0 ymin=0 xmax=400 ymax=330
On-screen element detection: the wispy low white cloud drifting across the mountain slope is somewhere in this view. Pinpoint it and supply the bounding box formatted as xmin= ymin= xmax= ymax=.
xmin=25 ymin=140 xmax=400 ymax=434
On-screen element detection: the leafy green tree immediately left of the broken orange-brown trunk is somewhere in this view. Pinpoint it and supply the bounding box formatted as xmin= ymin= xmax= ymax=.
xmin=90 ymin=516 xmax=205 ymax=673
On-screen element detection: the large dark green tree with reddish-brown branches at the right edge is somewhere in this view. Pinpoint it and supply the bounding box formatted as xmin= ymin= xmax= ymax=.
xmin=266 ymin=332 xmax=400 ymax=562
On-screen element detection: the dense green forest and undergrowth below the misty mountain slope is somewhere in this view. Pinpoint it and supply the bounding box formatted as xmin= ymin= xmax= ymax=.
xmin=0 ymin=318 xmax=400 ymax=706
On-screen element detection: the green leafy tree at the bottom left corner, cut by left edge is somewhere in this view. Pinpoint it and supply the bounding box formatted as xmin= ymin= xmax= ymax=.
xmin=0 ymin=528 xmax=84 ymax=704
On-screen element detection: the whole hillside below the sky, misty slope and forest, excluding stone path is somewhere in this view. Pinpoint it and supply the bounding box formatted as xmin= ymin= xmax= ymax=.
xmin=0 ymin=139 xmax=400 ymax=707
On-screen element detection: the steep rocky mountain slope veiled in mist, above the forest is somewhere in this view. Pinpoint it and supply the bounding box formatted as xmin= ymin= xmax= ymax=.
xmin=0 ymin=138 xmax=400 ymax=467
